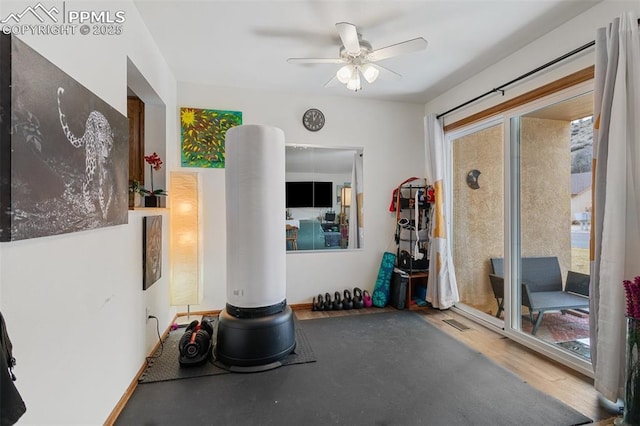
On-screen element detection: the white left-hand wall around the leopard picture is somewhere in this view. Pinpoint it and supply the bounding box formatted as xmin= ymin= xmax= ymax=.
xmin=0 ymin=1 xmax=176 ymax=425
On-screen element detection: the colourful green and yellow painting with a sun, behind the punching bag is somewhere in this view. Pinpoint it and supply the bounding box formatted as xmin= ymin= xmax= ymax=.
xmin=180 ymin=108 xmax=242 ymax=169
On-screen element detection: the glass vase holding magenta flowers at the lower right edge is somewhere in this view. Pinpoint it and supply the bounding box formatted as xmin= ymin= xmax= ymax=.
xmin=622 ymin=317 xmax=640 ymax=425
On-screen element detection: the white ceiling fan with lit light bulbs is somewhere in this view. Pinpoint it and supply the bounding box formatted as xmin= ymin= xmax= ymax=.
xmin=287 ymin=22 xmax=427 ymax=92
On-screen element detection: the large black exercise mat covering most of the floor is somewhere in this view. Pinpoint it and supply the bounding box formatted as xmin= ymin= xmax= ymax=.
xmin=116 ymin=310 xmax=591 ymax=426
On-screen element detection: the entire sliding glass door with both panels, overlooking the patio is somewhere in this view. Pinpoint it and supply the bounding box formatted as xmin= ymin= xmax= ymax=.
xmin=447 ymin=84 xmax=593 ymax=371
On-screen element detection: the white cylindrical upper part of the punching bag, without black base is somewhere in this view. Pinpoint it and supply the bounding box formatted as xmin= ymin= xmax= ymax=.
xmin=225 ymin=125 xmax=286 ymax=308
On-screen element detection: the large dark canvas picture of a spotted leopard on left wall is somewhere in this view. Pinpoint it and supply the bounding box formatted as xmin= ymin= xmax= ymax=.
xmin=0 ymin=34 xmax=129 ymax=241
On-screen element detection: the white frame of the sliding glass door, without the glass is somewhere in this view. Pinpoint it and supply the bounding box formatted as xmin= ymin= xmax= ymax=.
xmin=445 ymin=81 xmax=593 ymax=378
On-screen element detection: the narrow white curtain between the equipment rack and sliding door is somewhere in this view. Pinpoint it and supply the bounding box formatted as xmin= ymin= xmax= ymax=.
xmin=425 ymin=114 xmax=460 ymax=309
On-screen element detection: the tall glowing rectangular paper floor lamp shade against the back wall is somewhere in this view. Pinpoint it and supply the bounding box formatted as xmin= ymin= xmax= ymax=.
xmin=169 ymin=172 xmax=202 ymax=305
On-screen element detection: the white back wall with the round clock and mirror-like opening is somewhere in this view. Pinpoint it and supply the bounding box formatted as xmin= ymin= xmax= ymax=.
xmin=174 ymin=83 xmax=424 ymax=309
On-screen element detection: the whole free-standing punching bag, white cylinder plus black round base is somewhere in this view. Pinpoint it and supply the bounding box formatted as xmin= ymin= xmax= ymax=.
xmin=214 ymin=125 xmax=296 ymax=371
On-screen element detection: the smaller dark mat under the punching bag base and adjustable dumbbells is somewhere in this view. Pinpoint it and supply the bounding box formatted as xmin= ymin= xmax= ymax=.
xmin=138 ymin=325 xmax=316 ymax=383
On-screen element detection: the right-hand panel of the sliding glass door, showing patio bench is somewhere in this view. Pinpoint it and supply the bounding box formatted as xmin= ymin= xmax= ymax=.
xmin=509 ymin=92 xmax=593 ymax=362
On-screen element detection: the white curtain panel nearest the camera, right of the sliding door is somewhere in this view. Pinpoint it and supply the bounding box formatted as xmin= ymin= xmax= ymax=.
xmin=590 ymin=13 xmax=640 ymax=401
